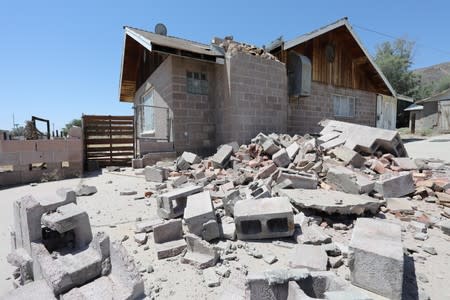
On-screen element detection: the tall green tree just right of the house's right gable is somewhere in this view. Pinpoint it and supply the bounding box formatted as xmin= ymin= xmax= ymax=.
xmin=375 ymin=39 xmax=431 ymax=99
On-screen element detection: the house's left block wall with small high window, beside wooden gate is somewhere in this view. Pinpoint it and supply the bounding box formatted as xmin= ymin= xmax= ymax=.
xmin=135 ymin=56 xmax=216 ymax=155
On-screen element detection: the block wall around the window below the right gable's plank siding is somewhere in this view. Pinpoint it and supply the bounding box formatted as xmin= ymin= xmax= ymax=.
xmin=288 ymin=81 xmax=377 ymax=134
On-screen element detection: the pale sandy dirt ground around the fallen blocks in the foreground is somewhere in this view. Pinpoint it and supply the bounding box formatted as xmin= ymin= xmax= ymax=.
xmin=0 ymin=165 xmax=450 ymax=299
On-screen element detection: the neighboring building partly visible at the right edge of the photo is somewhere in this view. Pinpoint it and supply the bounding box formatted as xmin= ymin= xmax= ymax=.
xmin=405 ymin=89 xmax=450 ymax=132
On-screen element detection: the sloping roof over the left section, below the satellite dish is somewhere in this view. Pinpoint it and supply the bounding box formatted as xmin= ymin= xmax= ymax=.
xmin=124 ymin=26 xmax=222 ymax=56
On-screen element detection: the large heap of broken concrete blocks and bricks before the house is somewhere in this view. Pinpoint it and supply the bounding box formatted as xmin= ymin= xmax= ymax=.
xmin=4 ymin=121 xmax=450 ymax=299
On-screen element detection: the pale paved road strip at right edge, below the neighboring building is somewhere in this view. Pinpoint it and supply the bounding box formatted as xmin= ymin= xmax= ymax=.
xmin=405 ymin=134 xmax=450 ymax=162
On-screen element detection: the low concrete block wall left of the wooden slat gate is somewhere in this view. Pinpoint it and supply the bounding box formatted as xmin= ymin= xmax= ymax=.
xmin=0 ymin=139 xmax=83 ymax=187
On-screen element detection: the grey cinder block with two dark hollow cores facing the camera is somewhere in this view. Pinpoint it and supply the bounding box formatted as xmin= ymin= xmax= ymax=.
xmin=234 ymin=197 xmax=294 ymax=240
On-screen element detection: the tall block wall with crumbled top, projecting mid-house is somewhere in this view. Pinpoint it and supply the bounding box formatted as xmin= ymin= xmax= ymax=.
xmin=216 ymin=52 xmax=288 ymax=144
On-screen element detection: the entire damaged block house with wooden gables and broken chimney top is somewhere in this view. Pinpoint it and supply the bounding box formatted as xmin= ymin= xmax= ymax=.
xmin=120 ymin=18 xmax=397 ymax=155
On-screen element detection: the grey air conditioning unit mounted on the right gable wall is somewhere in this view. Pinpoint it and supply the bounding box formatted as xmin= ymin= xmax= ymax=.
xmin=287 ymin=51 xmax=311 ymax=97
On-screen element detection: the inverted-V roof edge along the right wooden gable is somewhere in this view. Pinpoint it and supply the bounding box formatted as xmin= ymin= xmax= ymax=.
xmin=283 ymin=18 xmax=397 ymax=97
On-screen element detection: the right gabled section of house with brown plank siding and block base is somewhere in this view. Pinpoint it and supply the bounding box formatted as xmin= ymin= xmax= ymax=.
xmin=269 ymin=18 xmax=397 ymax=132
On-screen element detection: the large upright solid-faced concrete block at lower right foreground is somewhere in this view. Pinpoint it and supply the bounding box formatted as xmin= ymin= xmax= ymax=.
xmin=349 ymin=218 xmax=403 ymax=299
